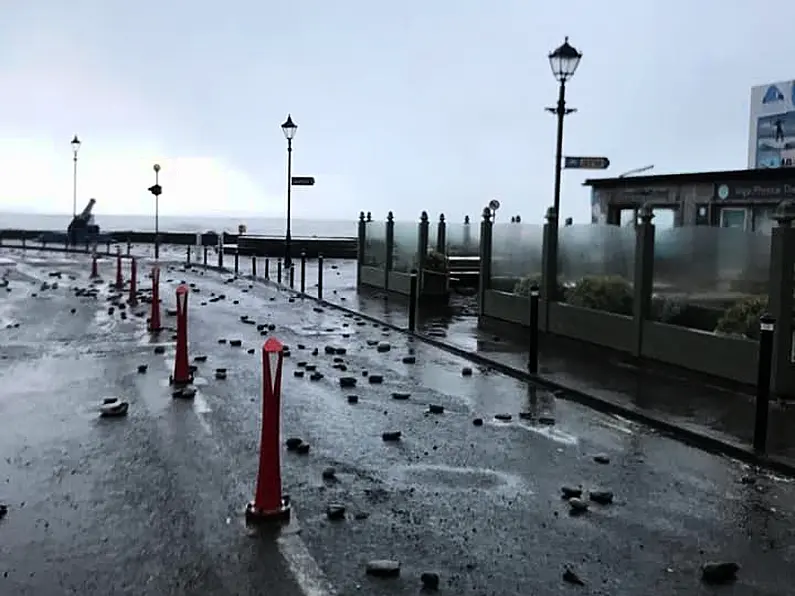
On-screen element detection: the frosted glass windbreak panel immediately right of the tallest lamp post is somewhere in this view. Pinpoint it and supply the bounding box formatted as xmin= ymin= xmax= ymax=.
xmin=558 ymin=224 xmax=635 ymax=285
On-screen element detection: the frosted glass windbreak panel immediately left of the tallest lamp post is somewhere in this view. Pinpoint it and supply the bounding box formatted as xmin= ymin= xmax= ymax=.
xmin=492 ymin=223 xmax=544 ymax=294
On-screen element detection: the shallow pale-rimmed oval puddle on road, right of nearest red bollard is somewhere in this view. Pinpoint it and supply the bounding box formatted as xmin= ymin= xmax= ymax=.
xmin=394 ymin=465 xmax=522 ymax=490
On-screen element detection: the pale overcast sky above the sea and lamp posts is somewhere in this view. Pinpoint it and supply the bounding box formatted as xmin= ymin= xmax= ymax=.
xmin=0 ymin=0 xmax=795 ymax=222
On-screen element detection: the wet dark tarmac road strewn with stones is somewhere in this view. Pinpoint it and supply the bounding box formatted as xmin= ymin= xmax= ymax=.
xmin=0 ymin=251 xmax=795 ymax=596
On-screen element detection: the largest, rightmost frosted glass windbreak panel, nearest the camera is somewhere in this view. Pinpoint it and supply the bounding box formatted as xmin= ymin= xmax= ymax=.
xmin=653 ymin=226 xmax=770 ymax=331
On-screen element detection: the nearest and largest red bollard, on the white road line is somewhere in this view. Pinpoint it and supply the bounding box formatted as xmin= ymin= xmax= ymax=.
xmin=246 ymin=337 xmax=290 ymax=523
